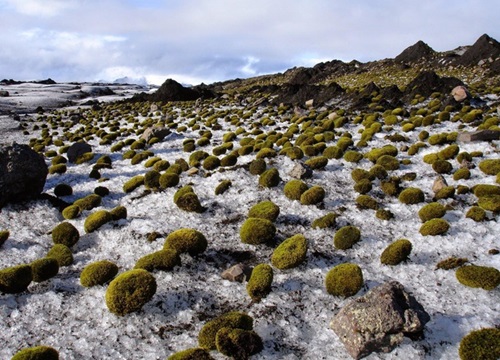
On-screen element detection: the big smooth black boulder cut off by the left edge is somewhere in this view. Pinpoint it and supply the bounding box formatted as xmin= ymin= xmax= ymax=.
xmin=0 ymin=143 xmax=48 ymax=208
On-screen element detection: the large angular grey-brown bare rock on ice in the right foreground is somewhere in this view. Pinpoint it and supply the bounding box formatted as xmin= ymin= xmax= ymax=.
xmin=330 ymin=281 xmax=430 ymax=359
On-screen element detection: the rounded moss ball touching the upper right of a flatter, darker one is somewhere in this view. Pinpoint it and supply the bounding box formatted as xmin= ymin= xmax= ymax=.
xmin=163 ymin=228 xmax=208 ymax=256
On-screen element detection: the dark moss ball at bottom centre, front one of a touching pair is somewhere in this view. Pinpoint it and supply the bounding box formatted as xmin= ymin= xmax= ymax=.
xmin=215 ymin=328 xmax=264 ymax=359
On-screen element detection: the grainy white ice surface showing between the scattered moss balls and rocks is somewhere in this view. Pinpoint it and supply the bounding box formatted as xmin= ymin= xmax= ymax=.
xmin=0 ymin=88 xmax=500 ymax=360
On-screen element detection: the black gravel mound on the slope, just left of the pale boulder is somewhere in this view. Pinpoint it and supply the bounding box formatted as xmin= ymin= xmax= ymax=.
xmin=405 ymin=71 xmax=464 ymax=100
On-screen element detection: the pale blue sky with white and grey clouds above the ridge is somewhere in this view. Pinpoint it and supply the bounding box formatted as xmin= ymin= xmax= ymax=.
xmin=0 ymin=0 xmax=500 ymax=84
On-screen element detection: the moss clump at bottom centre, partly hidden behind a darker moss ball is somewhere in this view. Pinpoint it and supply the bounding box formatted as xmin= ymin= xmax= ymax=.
xmin=198 ymin=311 xmax=253 ymax=350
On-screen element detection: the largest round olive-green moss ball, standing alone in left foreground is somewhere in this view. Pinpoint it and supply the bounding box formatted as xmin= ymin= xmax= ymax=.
xmin=106 ymin=269 xmax=157 ymax=316
